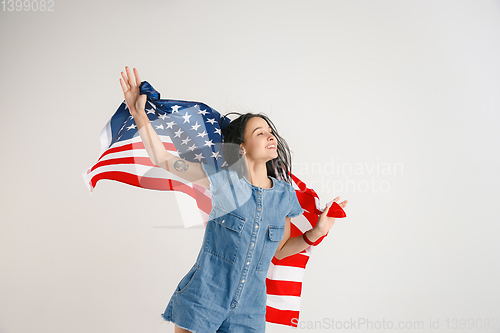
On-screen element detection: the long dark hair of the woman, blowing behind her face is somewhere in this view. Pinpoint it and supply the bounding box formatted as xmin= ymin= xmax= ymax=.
xmin=218 ymin=112 xmax=292 ymax=184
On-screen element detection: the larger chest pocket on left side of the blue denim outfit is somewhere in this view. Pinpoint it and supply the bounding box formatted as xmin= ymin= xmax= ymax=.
xmin=203 ymin=206 xmax=246 ymax=263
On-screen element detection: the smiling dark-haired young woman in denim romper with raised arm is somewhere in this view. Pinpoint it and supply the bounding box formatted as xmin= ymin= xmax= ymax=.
xmin=120 ymin=67 xmax=347 ymax=333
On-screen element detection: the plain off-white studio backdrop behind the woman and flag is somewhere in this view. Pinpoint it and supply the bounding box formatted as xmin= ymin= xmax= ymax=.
xmin=0 ymin=0 xmax=500 ymax=333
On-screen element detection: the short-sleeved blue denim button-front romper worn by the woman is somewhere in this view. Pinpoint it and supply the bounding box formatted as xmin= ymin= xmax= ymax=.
xmin=162 ymin=163 xmax=303 ymax=333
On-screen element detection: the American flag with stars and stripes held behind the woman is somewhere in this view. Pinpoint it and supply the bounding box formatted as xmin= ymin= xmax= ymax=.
xmin=83 ymin=81 xmax=334 ymax=327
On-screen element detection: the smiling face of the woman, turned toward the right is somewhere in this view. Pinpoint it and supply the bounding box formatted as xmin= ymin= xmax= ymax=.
xmin=240 ymin=117 xmax=278 ymax=163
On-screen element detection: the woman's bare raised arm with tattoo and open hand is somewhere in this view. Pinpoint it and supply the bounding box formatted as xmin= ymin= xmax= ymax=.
xmin=120 ymin=67 xmax=210 ymax=189
